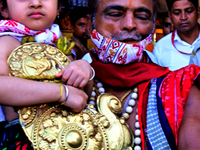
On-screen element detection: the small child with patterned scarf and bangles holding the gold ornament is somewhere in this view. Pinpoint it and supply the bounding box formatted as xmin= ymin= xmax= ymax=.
xmin=0 ymin=0 xmax=92 ymax=149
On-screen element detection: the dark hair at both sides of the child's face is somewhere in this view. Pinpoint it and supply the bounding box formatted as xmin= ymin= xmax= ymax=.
xmin=0 ymin=0 xmax=69 ymax=19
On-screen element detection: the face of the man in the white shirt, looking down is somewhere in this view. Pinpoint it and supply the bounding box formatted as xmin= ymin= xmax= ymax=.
xmin=170 ymin=0 xmax=198 ymax=33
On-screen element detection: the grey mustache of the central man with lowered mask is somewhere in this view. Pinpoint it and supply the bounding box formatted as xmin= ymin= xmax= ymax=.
xmin=112 ymin=31 xmax=142 ymax=42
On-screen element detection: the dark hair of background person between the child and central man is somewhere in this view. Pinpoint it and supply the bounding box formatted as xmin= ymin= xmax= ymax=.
xmin=69 ymin=7 xmax=89 ymax=26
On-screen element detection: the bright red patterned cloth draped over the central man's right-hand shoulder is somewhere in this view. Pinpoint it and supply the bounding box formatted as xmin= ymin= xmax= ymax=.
xmin=160 ymin=65 xmax=200 ymax=142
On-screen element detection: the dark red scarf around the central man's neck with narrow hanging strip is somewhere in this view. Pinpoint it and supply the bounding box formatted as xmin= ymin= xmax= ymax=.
xmin=91 ymin=54 xmax=169 ymax=149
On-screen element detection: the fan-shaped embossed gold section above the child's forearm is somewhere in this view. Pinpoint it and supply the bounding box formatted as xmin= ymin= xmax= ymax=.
xmin=7 ymin=43 xmax=70 ymax=79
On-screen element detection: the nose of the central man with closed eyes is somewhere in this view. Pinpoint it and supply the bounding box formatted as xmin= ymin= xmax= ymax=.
xmin=121 ymin=12 xmax=136 ymax=32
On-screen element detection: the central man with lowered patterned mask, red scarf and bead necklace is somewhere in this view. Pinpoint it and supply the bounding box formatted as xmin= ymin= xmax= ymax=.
xmin=89 ymin=0 xmax=200 ymax=150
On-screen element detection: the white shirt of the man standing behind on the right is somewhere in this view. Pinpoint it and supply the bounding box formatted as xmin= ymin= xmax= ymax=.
xmin=153 ymin=31 xmax=200 ymax=71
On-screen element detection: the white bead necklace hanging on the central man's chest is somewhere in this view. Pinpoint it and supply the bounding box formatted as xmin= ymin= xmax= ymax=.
xmin=89 ymin=81 xmax=141 ymax=150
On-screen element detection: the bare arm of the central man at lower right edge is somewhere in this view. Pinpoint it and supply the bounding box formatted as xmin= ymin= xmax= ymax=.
xmin=178 ymin=85 xmax=200 ymax=150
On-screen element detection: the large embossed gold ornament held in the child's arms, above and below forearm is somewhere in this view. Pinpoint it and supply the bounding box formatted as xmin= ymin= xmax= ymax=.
xmin=7 ymin=43 xmax=134 ymax=150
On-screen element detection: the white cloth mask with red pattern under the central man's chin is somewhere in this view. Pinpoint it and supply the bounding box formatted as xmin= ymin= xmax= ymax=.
xmin=91 ymin=30 xmax=152 ymax=64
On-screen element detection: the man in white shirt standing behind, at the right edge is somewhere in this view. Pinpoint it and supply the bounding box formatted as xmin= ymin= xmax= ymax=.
xmin=153 ymin=0 xmax=200 ymax=71
